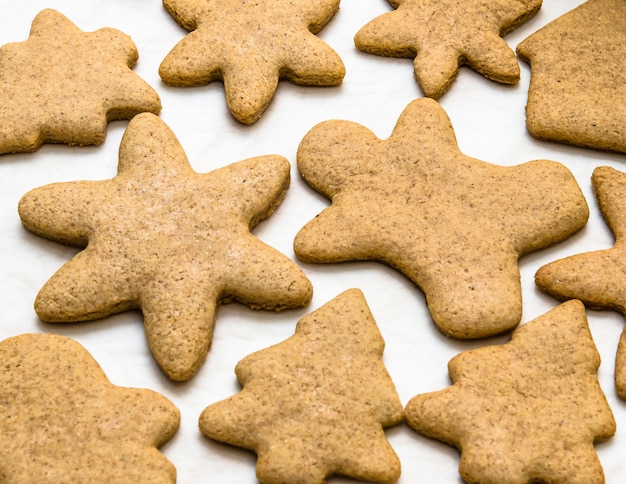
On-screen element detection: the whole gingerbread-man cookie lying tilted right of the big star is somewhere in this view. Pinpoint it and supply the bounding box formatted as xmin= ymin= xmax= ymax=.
xmin=294 ymin=98 xmax=589 ymax=338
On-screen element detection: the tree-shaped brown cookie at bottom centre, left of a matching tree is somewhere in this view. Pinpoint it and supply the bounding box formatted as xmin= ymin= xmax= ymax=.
xmin=199 ymin=289 xmax=403 ymax=484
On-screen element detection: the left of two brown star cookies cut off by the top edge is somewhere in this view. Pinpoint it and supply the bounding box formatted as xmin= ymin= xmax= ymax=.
xmin=159 ymin=0 xmax=345 ymax=124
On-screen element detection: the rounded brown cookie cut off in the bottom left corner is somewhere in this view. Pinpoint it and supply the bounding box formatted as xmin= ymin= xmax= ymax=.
xmin=0 ymin=334 xmax=180 ymax=483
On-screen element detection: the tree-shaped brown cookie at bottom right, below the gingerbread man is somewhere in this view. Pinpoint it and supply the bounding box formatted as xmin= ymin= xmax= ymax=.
xmin=406 ymin=300 xmax=615 ymax=484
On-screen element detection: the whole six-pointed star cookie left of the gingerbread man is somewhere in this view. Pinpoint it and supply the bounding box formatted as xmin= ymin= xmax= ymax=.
xmin=19 ymin=113 xmax=312 ymax=380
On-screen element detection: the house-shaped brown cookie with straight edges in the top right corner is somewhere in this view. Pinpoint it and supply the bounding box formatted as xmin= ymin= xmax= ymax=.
xmin=517 ymin=0 xmax=626 ymax=153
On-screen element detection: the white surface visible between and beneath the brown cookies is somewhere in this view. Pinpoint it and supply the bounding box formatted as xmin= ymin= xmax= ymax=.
xmin=0 ymin=0 xmax=626 ymax=483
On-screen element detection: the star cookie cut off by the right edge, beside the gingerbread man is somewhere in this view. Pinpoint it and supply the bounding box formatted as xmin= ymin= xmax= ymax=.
xmin=535 ymin=166 xmax=626 ymax=399
